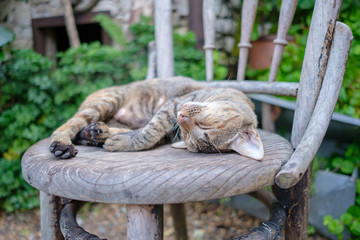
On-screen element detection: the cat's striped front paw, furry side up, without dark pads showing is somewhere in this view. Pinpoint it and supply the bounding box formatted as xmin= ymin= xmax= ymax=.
xmin=103 ymin=132 xmax=138 ymax=152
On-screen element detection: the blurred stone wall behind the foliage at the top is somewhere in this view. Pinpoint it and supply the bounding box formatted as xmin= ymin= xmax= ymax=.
xmin=0 ymin=0 xmax=240 ymax=53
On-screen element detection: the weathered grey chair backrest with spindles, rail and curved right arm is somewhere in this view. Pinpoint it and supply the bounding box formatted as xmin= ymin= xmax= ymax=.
xmin=155 ymin=0 xmax=352 ymax=187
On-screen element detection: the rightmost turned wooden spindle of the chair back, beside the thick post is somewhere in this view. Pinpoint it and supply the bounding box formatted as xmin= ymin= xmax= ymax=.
xmin=269 ymin=0 xmax=298 ymax=82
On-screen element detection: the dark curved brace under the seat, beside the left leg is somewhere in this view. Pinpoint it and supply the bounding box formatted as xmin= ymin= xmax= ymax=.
xmin=60 ymin=201 xmax=106 ymax=240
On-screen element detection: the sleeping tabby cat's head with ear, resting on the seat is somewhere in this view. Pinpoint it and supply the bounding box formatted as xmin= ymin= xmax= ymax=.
xmin=177 ymin=101 xmax=264 ymax=160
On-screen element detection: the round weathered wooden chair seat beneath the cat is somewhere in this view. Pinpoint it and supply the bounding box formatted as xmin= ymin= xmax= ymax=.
xmin=22 ymin=130 xmax=293 ymax=204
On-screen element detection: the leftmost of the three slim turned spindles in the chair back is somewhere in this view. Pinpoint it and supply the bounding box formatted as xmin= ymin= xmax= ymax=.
xmin=203 ymin=0 xmax=216 ymax=82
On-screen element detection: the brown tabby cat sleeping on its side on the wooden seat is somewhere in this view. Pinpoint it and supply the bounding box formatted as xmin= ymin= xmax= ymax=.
xmin=50 ymin=77 xmax=264 ymax=160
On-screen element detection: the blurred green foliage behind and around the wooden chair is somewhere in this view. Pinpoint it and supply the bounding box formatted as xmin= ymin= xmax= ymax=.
xmin=0 ymin=0 xmax=360 ymax=236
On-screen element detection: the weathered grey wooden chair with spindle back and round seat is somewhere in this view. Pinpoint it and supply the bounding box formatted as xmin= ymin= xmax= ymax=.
xmin=22 ymin=0 xmax=352 ymax=240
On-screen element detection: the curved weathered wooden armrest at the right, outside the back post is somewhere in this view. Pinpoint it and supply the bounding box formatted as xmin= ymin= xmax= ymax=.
xmin=275 ymin=22 xmax=352 ymax=188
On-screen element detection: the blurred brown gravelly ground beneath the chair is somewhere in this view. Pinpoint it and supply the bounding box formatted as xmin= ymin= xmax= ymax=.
xmin=0 ymin=202 xmax=326 ymax=240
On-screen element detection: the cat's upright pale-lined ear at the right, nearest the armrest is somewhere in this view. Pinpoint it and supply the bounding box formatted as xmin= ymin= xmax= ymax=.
xmin=230 ymin=124 xmax=264 ymax=160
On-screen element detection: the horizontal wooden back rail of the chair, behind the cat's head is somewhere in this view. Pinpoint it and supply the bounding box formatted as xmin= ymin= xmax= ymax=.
xmin=206 ymin=80 xmax=299 ymax=97
